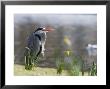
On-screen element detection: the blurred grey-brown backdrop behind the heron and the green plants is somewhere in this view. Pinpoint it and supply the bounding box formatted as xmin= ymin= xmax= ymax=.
xmin=14 ymin=14 xmax=97 ymax=73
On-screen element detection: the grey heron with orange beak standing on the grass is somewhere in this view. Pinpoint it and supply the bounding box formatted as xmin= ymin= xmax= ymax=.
xmin=25 ymin=27 xmax=53 ymax=70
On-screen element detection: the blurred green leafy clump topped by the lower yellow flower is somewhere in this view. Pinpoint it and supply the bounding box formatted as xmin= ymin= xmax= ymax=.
xmin=64 ymin=49 xmax=81 ymax=76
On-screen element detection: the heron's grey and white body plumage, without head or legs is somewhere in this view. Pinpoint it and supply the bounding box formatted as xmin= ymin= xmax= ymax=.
xmin=27 ymin=31 xmax=46 ymax=55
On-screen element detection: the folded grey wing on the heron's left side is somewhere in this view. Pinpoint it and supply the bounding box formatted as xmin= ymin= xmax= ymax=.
xmin=28 ymin=34 xmax=40 ymax=54
